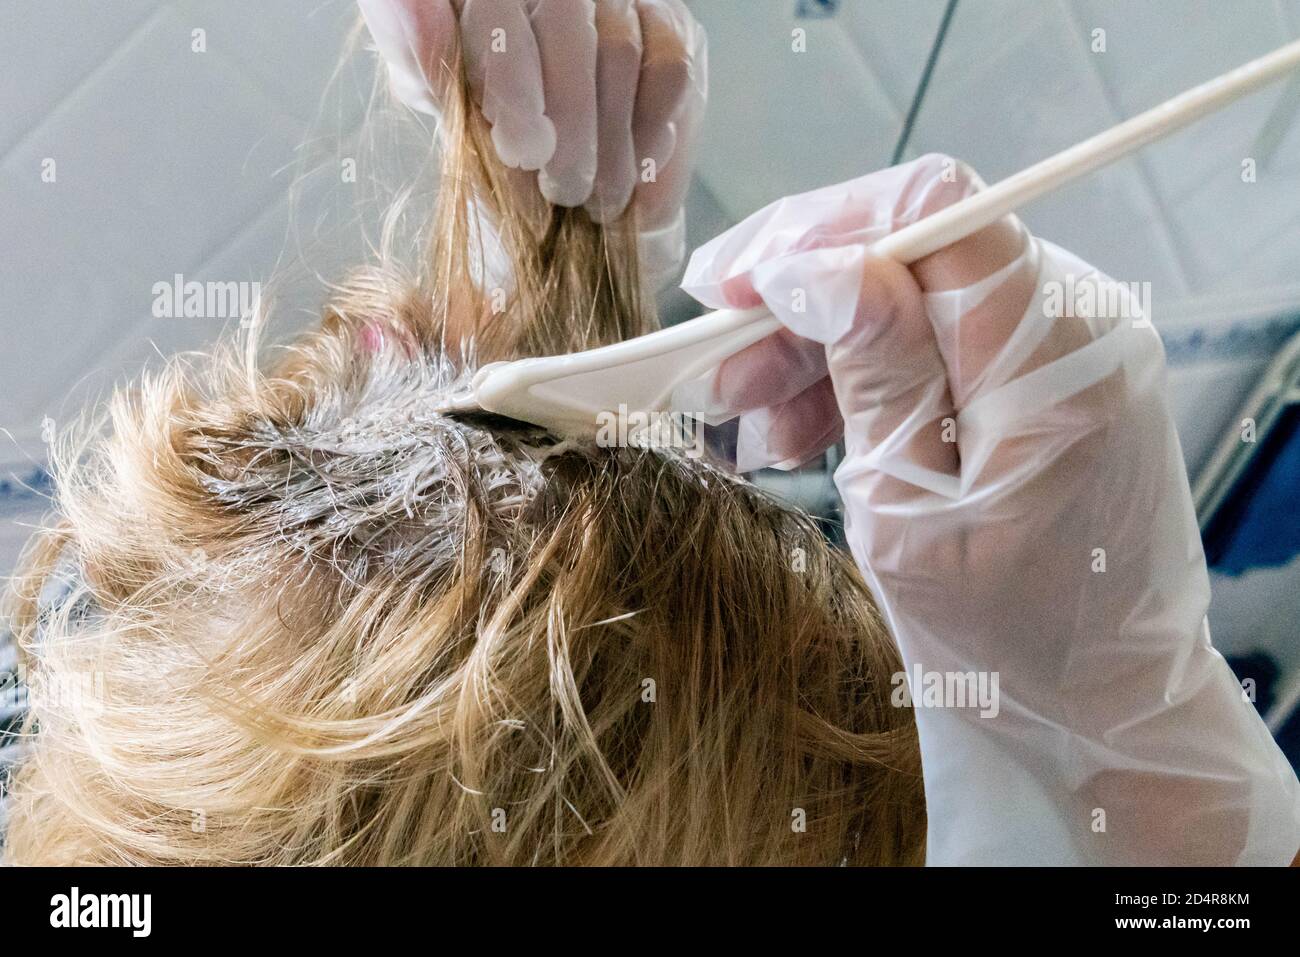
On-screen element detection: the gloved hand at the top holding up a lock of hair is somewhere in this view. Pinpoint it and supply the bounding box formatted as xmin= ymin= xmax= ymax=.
xmin=358 ymin=0 xmax=707 ymax=287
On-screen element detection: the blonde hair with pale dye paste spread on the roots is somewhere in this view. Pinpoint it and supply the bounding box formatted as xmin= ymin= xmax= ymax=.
xmin=5 ymin=39 xmax=924 ymax=865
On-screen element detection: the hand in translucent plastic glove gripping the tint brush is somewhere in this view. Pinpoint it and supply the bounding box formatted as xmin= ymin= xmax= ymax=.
xmin=675 ymin=156 xmax=1300 ymax=865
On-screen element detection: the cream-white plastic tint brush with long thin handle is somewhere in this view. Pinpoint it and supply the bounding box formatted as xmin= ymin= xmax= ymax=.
xmin=442 ymin=40 xmax=1300 ymax=434
